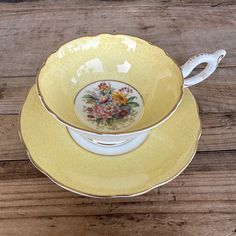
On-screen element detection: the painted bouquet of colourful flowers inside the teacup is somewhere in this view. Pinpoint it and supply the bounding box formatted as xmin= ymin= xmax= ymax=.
xmin=83 ymin=82 xmax=139 ymax=130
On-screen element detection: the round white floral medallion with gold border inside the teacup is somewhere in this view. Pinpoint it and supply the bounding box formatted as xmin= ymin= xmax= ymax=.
xmin=75 ymin=81 xmax=143 ymax=132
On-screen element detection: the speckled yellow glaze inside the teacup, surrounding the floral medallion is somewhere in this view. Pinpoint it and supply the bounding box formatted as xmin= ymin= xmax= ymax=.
xmin=37 ymin=34 xmax=183 ymax=133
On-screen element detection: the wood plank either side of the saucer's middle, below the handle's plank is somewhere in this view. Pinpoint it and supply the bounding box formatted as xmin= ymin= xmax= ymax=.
xmin=0 ymin=110 xmax=236 ymax=160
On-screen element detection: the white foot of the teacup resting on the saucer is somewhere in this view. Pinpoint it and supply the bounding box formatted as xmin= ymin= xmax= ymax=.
xmin=67 ymin=128 xmax=149 ymax=156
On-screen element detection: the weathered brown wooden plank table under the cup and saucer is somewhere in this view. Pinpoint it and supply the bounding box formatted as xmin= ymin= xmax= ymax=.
xmin=0 ymin=0 xmax=236 ymax=236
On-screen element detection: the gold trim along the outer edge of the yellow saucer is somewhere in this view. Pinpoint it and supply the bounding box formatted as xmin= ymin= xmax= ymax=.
xmin=18 ymin=87 xmax=202 ymax=198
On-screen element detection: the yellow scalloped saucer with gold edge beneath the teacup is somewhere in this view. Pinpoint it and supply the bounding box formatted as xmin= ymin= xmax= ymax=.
xmin=20 ymin=86 xmax=201 ymax=197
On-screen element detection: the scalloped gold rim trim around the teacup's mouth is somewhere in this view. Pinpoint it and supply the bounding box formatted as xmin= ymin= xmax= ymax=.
xmin=36 ymin=34 xmax=184 ymax=135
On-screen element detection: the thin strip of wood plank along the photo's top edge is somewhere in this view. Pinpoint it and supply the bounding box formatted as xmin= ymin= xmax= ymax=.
xmin=0 ymin=0 xmax=236 ymax=11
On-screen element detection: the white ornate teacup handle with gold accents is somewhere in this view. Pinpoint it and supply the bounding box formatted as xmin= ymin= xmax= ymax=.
xmin=181 ymin=49 xmax=226 ymax=87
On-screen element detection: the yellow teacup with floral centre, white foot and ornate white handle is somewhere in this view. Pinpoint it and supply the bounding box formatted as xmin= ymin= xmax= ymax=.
xmin=37 ymin=34 xmax=226 ymax=155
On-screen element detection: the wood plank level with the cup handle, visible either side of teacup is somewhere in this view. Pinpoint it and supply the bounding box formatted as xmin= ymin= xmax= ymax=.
xmin=0 ymin=68 xmax=236 ymax=114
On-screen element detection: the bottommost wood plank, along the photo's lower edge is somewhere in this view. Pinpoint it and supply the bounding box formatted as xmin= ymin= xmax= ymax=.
xmin=0 ymin=213 xmax=236 ymax=236
